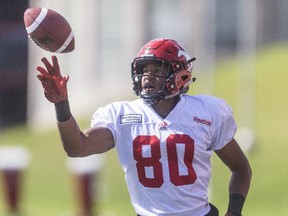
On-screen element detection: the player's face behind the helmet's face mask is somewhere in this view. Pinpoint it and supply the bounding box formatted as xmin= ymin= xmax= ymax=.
xmin=142 ymin=63 xmax=169 ymax=94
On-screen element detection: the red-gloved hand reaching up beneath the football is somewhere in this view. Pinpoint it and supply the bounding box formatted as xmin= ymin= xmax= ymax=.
xmin=37 ymin=55 xmax=69 ymax=103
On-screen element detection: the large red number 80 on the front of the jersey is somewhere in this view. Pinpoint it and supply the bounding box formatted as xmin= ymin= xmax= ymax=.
xmin=133 ymin=134 xmax=197 ymax=188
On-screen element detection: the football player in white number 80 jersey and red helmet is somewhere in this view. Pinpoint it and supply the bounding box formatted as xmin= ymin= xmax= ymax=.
xmin=37 ymin=38 xmax=251 ymax=216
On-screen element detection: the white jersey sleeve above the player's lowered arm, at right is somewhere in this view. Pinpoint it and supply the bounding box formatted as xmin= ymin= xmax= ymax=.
xmin=210 ymin=100 xmax=237 ymax=150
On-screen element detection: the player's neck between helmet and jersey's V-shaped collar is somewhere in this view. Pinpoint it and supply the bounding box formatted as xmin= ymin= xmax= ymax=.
xmin=152 ymin=95 xmax=180 ymax=119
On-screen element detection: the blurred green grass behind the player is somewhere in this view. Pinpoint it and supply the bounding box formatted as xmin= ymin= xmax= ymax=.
xmin=0 ymin=44 xmax=288 ymax=216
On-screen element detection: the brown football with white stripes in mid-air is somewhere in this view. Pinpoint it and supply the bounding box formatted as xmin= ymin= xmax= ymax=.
xmin=23 ymin=7 xmax=75 ymax=53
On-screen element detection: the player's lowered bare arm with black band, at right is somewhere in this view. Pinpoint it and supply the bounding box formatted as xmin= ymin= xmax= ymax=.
xmin=215 ymin=139 xmax=252 ymax=216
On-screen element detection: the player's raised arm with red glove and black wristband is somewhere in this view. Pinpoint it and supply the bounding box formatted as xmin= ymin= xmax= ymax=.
xmin=37 ymin=56 xmax=114 ymax=157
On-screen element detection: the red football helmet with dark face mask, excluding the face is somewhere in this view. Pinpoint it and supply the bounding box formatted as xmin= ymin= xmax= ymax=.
xmin=131 ymin=38 xmax=195 ymax=104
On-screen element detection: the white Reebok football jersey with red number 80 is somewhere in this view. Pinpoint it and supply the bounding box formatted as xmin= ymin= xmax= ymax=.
xmin=91 ymin=95 xmax=236 ymax=216
